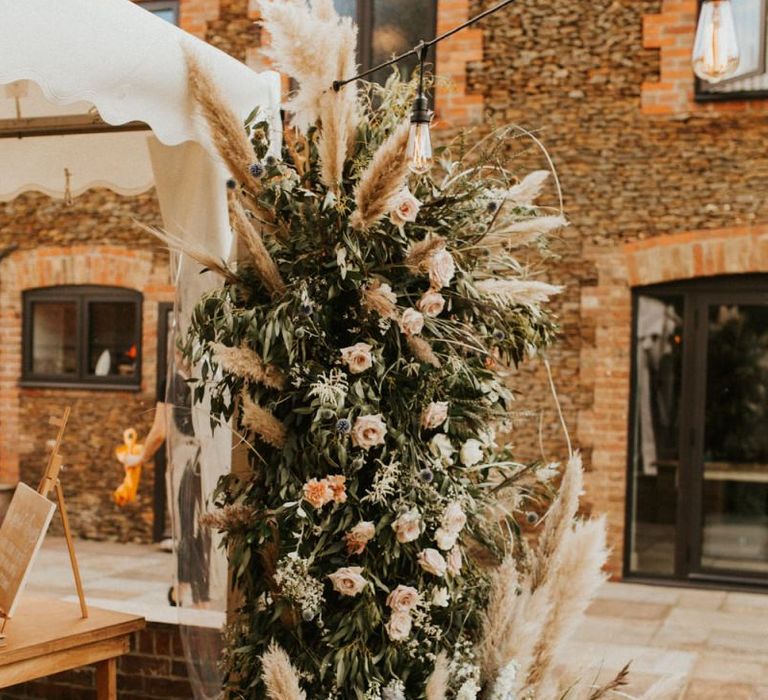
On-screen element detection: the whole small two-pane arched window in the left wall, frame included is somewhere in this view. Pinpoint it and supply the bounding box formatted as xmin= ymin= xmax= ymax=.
xmin=22 ymin=286 xmax=142 ymax=389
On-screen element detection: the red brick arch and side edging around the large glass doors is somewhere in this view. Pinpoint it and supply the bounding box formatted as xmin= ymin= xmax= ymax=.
xmin=578 ymin=226 xmax=768 ymax=576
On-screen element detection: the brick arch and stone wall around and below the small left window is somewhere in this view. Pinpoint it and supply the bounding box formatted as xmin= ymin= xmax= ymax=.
xmin=0 ymin=246 xmax=173 ymax=542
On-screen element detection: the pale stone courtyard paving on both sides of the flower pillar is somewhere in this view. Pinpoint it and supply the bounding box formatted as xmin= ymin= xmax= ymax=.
xmin=29 ymin=537 xmax=768 ymax=700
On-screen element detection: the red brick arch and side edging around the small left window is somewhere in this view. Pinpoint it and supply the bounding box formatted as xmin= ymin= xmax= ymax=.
xmin=0 ymin=245 xmax=174 ymax=483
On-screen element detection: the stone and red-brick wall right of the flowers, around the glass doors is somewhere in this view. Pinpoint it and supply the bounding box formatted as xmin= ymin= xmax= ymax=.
xmin=468 ymin=0 xmax=768 ymax=575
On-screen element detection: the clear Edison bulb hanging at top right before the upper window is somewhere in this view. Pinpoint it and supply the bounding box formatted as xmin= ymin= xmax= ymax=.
xmin=693 ymin=0 xmax=740 ymax=83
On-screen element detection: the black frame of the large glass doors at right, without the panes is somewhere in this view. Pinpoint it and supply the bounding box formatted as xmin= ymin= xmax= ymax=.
xmin=622 ymin=272 xmax=768 ymax=593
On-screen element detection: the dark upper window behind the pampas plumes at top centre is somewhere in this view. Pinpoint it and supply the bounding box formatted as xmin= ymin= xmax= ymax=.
xmin=334 ymin=0 xmax=437 ymax=82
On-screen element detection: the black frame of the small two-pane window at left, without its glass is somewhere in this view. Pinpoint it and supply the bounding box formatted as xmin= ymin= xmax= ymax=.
xmin=20 ymin=285 xmax=144 ymax=391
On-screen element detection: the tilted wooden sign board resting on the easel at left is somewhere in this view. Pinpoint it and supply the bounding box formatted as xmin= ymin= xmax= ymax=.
xmin=0 ymin=484 xmax=56 ymax=618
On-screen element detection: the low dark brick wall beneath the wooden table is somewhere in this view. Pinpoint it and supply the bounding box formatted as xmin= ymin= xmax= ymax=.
xmin=0 ymin=622 xmax=218 ymax=700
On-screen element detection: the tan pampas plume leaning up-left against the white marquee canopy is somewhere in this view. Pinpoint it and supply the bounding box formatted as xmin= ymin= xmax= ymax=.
xmin=184 ymin=48 xmax=261 ymax=192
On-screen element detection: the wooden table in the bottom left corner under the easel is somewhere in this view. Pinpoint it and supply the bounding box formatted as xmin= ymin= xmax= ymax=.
xmin=0 ymin=596 xmax=146 ymax=700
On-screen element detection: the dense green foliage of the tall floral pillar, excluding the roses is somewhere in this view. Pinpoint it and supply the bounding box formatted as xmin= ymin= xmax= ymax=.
xmin=182 ymin=77 xmax=556 ymax=700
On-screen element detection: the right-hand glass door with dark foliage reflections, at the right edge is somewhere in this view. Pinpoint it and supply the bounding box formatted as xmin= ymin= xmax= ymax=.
xmin=689 ymin=293 xmax=768 ymax=579
